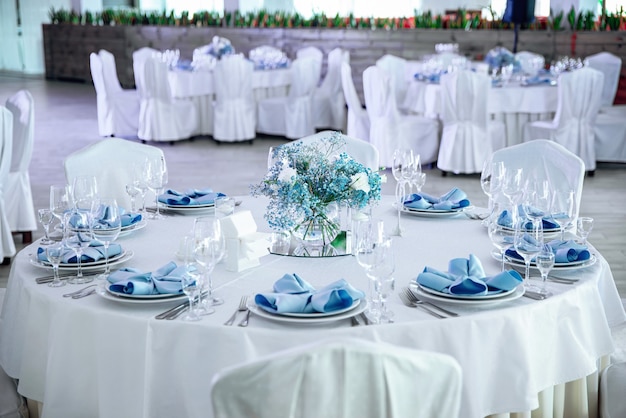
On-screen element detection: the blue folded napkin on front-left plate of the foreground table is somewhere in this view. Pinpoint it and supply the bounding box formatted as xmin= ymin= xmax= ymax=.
xmin=107 ymin=261 xmax=187 ymax=295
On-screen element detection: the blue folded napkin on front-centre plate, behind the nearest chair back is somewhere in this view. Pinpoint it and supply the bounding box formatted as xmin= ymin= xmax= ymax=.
xmin=254 ymin=274 xmax=365 ymax=313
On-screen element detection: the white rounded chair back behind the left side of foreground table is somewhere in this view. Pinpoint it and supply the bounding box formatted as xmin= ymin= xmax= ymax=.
xmin=63 ymin=138 xmax=165 ymax=211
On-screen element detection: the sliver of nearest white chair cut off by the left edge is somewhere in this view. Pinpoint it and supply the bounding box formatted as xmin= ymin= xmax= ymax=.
xmin=0 ymin=106 xmax=15 ymax=259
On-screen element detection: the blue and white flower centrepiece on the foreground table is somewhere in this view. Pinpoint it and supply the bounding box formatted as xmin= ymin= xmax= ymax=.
xmin=251 ymin=132 xmax=381 ymax=244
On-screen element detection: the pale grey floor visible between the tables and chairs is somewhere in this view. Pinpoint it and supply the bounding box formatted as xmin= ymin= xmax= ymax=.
xmin=0 ymin=75 xmax=626 ymax=298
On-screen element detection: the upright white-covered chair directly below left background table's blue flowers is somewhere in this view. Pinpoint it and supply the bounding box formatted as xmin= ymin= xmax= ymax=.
xmin=213 ymin=54 xmax=256 ymax=142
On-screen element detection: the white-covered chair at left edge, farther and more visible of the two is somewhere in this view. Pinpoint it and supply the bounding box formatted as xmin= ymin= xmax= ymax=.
xmin=4 ymin=90 xmax=37 ymax=243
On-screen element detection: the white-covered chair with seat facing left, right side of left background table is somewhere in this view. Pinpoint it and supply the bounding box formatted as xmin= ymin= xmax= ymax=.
xmin=257 ymin=58 xmax=317 ymax=139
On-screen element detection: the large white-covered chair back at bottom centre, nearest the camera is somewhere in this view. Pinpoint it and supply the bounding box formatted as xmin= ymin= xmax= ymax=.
xmin=211 ymin=338 xmax=462 ymax=418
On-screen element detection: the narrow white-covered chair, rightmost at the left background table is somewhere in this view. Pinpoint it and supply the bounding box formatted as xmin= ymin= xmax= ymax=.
xmin=313 ymin=48 xmax=350 ymax=131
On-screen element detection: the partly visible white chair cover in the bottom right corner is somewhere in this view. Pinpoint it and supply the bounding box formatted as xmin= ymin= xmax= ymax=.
xmin=600 ymin=362 xmax=626 ymax=418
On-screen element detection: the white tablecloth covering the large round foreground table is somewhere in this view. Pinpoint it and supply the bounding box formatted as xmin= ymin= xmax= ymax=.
xmin=0 ymin=196 xmax=626 ymax=418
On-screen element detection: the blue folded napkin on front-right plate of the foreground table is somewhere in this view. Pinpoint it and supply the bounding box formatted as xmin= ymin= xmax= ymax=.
xmin=416 ymin=254 xmax=522 ymax=296
